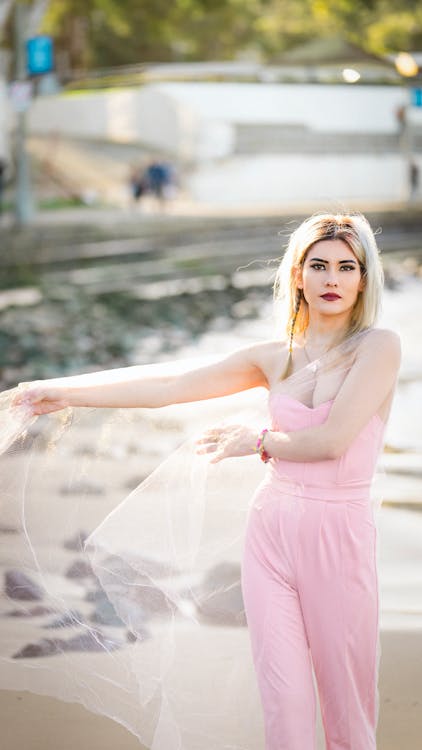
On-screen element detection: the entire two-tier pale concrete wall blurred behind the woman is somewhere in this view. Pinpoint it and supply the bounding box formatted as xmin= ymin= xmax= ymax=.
xmin=30 ymin=82 xmax=422 ymax=206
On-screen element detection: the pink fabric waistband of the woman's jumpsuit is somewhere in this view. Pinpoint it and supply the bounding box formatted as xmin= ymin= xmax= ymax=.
xmin=264 ymin=467 xmax=371 ymax=503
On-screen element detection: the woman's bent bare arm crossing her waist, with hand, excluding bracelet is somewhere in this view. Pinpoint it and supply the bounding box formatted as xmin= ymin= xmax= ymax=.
xmin=198 ymin=330 xmax=401 ymax=463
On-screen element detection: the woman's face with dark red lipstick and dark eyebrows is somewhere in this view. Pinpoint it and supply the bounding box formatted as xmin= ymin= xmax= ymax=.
xmin=297 ymin=239 xmax=364 ymax=316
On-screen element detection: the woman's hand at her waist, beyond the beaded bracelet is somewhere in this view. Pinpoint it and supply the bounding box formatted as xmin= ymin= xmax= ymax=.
xmin=196 ymin=424 xmax=258 ymax=464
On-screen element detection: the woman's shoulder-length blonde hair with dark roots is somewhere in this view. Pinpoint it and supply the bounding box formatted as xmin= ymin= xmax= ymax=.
xmin=274 ymin=213 xmax=384 ymax=339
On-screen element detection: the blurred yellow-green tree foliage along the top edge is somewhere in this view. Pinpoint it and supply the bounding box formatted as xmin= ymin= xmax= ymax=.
xmin=1 ymin=0 xmax=422 ymax=68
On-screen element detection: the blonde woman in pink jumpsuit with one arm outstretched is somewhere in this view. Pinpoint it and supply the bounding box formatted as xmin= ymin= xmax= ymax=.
xmin=9 ymin=214 xmax=400 ymax=750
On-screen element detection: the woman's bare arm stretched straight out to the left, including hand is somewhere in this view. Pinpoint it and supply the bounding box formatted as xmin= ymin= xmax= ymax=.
xmin=15 ymin=343 xmax=269 ymax=414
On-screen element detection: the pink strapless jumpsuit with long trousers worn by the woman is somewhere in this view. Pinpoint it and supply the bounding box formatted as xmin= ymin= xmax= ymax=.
xmin=242 ymin=392 xmax=384 ymax=750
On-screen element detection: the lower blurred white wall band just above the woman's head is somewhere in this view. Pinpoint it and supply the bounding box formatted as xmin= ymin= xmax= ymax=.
xmin=188 ymin=154 xmax=408 ymax=209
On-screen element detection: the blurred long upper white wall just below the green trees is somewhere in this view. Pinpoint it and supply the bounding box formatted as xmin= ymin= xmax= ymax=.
xmin=30 ymin=83 xmax=407 ymax=159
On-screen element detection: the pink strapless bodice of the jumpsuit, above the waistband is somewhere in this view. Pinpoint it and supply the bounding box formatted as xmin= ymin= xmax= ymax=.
xmin=268 ymin=391 xmax=385 ymax=497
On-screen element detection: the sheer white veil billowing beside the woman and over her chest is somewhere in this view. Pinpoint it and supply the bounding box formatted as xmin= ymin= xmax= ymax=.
xmin=0 ymin=330 xmax=392 ymax=750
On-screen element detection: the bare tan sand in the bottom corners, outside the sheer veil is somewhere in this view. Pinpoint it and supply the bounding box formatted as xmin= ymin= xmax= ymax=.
xmin=0 ymin=629 xmax=422 ymax=750
